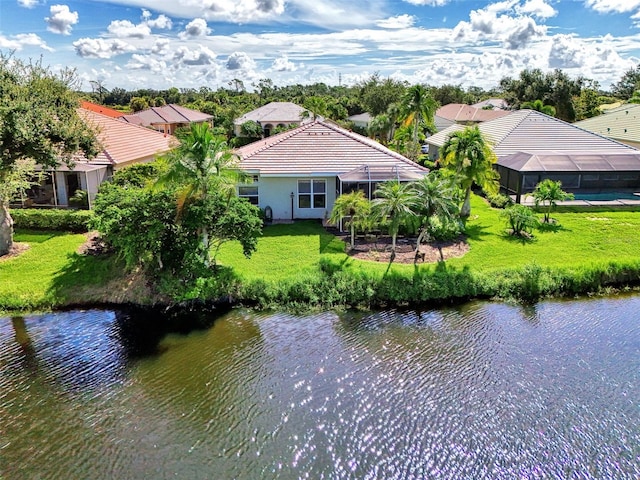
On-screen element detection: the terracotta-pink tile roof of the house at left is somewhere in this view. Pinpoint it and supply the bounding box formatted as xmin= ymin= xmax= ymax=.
xmin=78 ymin=109 xmax=177 ymax=166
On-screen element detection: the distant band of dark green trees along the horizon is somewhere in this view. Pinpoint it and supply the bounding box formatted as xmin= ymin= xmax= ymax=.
xmin=84 ymin=65 xmax=640 ymax=138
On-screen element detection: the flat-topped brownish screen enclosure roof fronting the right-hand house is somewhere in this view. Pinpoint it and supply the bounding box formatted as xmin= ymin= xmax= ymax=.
xmin=498 ymin=151 xmax=640 ymax=172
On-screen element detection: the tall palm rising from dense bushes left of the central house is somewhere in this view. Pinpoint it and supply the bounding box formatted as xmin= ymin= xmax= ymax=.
xmin=154 ymin=123 xmax=246 ymax=265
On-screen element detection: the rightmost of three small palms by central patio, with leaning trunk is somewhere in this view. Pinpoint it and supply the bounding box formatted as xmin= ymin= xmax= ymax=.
xmin=413 ymin=172 xmax=458 ymax=258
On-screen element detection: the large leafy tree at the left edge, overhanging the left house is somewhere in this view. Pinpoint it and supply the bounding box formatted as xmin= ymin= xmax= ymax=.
xmin=0 ymin=55 xmax=99 ymax=255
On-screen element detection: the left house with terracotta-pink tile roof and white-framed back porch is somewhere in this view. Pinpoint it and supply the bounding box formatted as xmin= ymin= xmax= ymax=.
xmin=23 ymin=109 xmax=177 ymax=207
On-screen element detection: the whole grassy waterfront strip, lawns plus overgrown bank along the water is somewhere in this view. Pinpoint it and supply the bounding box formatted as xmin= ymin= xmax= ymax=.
xmin=0 ymin=193 xmax=640 ymax=311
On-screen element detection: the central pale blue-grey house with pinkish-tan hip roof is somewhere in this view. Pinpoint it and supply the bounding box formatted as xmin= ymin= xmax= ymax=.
xmin=236 ymin=120 xmax=428 ymax=220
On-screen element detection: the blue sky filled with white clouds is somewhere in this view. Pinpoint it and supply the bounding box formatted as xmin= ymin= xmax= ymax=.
xmin=0 ymin=0 xmax=640 ymax=91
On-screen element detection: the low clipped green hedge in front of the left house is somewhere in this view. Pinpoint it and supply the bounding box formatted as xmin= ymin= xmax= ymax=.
xmin=11 ymin=208 xmax=93 ymax=233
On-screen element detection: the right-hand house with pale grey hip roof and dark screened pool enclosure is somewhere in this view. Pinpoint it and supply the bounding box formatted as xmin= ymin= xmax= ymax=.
xmin=427 ymin=110 xmax=640 ymax=202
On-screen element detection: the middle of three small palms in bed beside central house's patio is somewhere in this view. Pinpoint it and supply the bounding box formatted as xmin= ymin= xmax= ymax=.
xmin=371 ymin=180 xmax=418 ymax=255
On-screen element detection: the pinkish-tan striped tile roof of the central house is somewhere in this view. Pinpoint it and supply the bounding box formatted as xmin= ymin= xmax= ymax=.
xmin=236 ymin=120 xmax=428 ymax=176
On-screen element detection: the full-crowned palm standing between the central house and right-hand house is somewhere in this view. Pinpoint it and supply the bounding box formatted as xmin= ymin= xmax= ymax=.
xmin=440 ymin=125 xmax=499 ymax=218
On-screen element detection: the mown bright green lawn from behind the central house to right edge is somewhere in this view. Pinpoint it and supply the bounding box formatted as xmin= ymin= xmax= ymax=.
xmin=218 ymin=193 xmax=640 ymax=281
